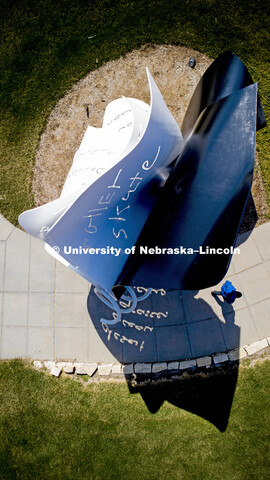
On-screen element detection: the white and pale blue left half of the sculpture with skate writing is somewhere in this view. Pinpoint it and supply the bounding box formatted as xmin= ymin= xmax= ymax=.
xmin=19 ymin=68 xmax=183 ymax=290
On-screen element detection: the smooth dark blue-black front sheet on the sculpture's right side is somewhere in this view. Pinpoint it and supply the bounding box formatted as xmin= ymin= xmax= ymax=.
xmin=118 ymin=84 xmax=257 ymax=290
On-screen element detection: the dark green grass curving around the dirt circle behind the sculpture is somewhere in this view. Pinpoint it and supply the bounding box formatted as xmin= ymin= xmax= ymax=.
xmin=0 ymin=0 xmax=270 ymax=223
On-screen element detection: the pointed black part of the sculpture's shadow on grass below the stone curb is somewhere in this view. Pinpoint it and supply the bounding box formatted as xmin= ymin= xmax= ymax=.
xmin=128 ymin=361 xmax=239 ymax=432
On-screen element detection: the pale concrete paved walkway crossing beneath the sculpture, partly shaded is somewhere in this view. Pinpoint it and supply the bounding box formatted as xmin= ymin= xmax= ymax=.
xmin=0 ymin=216 xmax=270 ymax=363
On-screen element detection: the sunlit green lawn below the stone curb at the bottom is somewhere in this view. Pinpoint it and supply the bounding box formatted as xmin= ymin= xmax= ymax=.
xmin=0 ymin=360 xmax=270 ymax=480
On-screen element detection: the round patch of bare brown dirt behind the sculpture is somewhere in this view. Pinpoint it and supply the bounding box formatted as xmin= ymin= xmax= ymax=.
xmin=32 ymin=45 xmax=267 ymax=231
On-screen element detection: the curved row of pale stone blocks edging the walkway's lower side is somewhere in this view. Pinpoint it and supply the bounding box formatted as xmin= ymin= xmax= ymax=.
xmin=30 ymin=337 xmax=270 ymax=381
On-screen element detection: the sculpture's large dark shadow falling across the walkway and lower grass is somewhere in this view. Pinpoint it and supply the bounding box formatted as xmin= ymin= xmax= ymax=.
xmin=88 ymin=289 xmax=240 ymax=432
